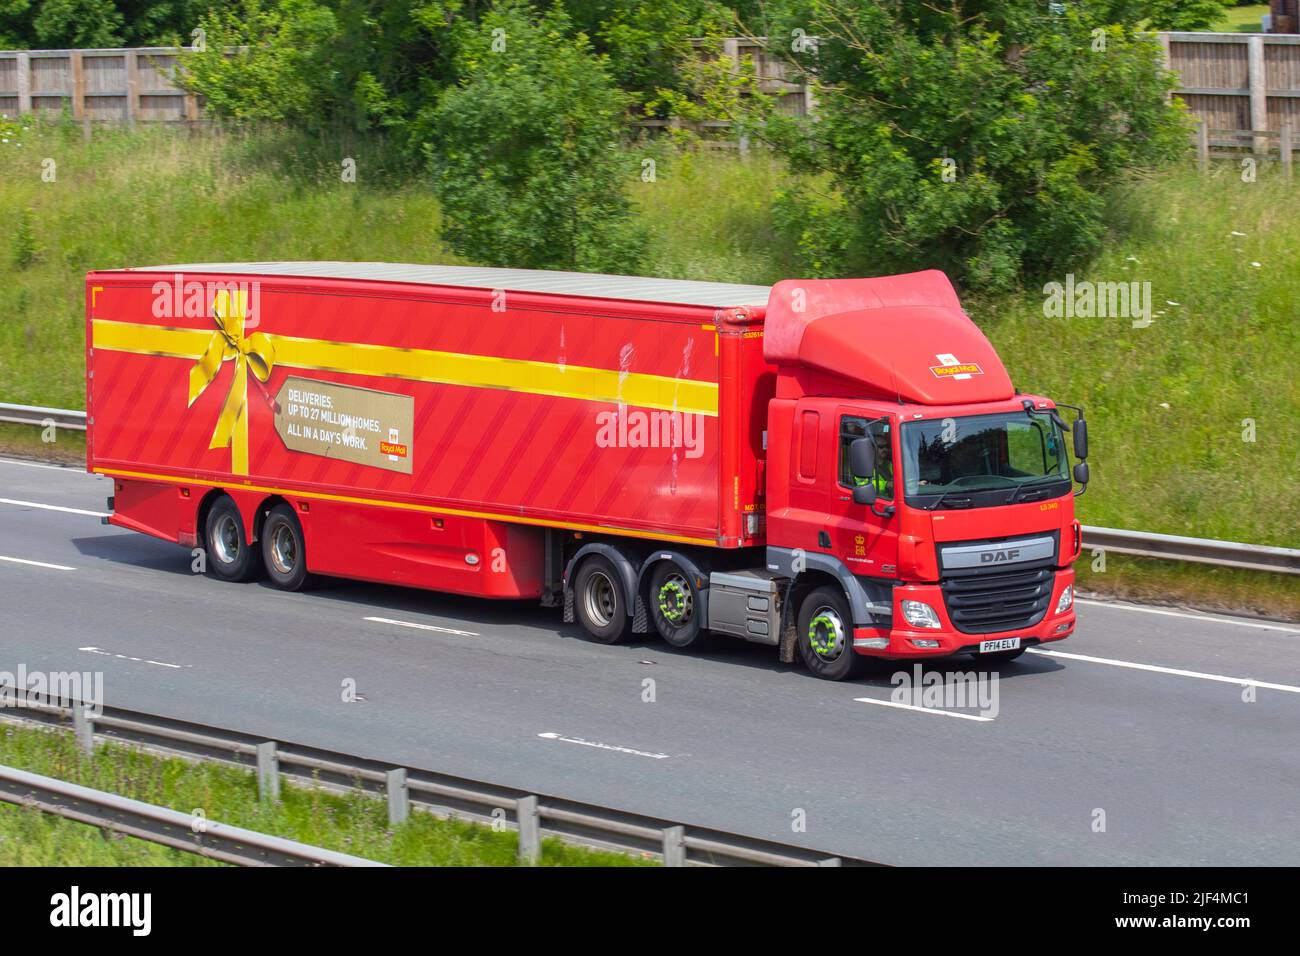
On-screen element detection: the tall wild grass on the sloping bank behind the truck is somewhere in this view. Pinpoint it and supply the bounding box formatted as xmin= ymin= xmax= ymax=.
xmin=0 ymin=124 xmax=1300 ymax=606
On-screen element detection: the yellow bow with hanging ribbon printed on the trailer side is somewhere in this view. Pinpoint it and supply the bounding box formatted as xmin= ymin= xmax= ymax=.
xmin=190 ymin=290 xmax=276 ymax=475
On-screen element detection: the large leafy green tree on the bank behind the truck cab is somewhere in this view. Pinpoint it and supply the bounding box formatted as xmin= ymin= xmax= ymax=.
xmin=764 ymin=0 xmax=1186 ymax=289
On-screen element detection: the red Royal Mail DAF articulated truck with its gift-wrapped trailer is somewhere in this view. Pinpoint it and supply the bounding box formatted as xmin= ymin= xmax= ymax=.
xmin=86 ymin=261 xmax=1088 ymax=680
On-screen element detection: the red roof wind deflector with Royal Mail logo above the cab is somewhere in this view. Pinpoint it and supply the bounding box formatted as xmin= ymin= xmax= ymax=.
xmin=763 ymin=271 xmax=1015 ymax=405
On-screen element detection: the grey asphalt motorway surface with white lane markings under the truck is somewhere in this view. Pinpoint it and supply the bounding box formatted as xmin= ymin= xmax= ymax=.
xmin=0 ymin=459 xmax=1300 ymax=865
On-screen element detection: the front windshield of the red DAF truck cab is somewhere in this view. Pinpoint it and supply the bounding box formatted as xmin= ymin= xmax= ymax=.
xmin=901 ymin=412 xmax=1067 ymax=497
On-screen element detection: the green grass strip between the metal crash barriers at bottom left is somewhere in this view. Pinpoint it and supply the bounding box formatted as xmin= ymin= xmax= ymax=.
xmin=0 ymin=724 xmax=649 ymax=866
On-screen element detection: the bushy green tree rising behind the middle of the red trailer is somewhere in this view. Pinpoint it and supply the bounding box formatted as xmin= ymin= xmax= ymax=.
xmin=420 ymin=0 xmax=645 ymax=272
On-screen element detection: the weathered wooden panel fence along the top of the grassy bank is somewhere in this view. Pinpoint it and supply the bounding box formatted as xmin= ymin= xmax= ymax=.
xmin=0 ymin=33 xmax=1300 ymax=152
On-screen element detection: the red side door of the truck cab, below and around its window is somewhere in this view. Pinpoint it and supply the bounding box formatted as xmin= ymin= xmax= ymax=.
xmin=820 ymin=405 xmax=902 ymax=578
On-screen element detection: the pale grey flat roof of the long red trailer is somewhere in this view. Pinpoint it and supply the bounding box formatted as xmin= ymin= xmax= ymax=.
xmin=130 ymin=261 xmax=771 ymax=307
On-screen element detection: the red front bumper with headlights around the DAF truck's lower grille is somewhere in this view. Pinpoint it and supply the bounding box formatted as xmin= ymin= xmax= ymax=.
xmin=853 ymin=568 xmax=1075 ymax=661
